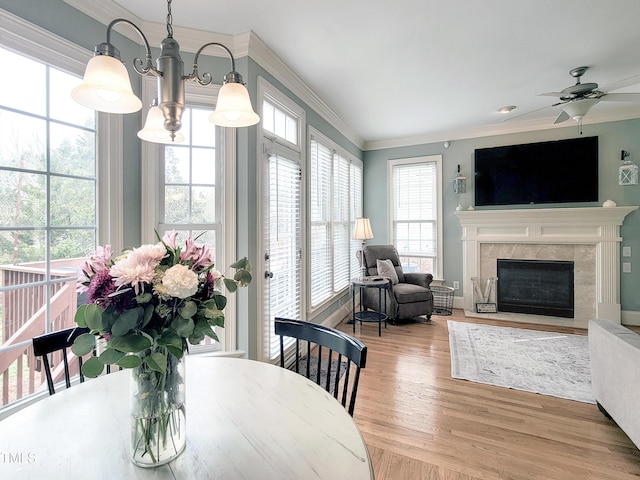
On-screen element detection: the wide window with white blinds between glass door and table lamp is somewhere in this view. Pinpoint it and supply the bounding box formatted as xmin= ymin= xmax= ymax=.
xmin=309 ymin=127 xmax=362 ymax=308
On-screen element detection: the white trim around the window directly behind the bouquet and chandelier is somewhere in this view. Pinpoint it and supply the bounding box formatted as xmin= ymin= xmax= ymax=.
xmin=140 ymin=76 xmax=237 ymax=352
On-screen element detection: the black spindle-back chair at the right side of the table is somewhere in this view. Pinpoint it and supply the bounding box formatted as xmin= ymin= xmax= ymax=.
xmin=275 ymin=318 xmax=367 ymax=416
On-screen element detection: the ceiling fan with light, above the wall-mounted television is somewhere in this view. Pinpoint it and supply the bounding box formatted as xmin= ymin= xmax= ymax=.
xmin=508 ymin=67 xmax=640 ymax=133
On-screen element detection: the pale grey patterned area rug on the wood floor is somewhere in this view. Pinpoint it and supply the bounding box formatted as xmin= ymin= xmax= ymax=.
xmin=448 ymin=320 xmax=596 ymax=403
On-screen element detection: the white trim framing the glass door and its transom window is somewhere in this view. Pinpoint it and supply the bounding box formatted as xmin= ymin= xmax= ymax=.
xmin=253 ymin=76 xmax=307 ymax=361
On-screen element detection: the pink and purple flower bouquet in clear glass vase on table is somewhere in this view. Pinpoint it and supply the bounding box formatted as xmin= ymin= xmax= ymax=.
xmin=72 ymin=231 xmax=251 ymax=466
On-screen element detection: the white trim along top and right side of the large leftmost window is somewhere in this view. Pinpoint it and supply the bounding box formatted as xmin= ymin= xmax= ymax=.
xmin=0 ymin=11 xmax=124 ymax=251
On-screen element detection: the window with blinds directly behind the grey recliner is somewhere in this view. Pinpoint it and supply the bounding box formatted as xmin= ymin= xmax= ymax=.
xmin=389 ymin=155 xmax=442 ymax=278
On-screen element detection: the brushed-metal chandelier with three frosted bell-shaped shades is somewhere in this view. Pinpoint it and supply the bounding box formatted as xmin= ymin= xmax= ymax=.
xmin=71 ymin=0 xmax=260 ymax=143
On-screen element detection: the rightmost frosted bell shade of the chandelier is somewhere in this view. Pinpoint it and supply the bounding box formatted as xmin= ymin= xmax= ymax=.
xmin=209 ymin=82 xmax=260 ymax=127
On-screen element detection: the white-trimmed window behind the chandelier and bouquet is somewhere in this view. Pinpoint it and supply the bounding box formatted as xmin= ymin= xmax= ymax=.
xmin=142 ymin=76 xmax=231 ymax=352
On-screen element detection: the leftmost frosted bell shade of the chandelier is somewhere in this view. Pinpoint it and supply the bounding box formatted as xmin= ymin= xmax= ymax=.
xmin=71 ymin=55 xmax=142 ymax=113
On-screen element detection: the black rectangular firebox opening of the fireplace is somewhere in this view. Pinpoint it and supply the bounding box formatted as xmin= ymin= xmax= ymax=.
xmin=497 ymin=258 xmax=574 ymax=318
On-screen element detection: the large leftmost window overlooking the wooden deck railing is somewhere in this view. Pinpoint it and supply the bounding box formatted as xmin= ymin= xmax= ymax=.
xmin=0 ymin=46 xmax=98 ymax=405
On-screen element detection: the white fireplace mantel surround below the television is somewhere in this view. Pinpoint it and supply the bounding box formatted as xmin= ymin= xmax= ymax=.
xmin=455 ymin=206 xmax=638 ymax=328
